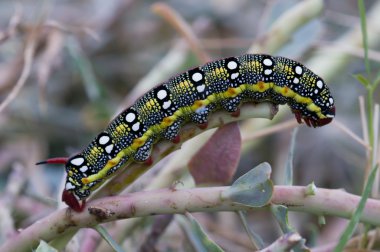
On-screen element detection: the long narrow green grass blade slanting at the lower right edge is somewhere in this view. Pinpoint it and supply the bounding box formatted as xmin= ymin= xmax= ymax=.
xmin=334 ymin=165 xmax=378 ymax=251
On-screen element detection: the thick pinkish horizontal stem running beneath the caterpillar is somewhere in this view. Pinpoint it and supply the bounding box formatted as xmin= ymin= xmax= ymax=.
xmin=0 ymin=186 xmax=380 ymax=251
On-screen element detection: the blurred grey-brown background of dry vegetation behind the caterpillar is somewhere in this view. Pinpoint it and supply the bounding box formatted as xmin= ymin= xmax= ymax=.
xmin=0 ymin=0 xmax=380 ymax=251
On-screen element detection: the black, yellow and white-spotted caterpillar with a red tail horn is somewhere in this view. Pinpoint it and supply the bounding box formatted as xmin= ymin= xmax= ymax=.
xmin=38 ymin=54 xmax=335 ymax=211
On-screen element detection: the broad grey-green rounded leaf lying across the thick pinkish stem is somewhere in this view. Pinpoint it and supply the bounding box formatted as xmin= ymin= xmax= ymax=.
xmin=222 ymin=163 xmax=273 ymax=207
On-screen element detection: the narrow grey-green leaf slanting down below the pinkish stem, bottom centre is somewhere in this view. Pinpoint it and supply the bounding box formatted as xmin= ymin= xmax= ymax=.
xmin=176 ymin=213 xmax=224 ymax=252
